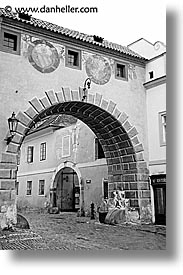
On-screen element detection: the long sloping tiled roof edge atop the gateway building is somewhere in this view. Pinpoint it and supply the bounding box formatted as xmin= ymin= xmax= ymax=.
xmin=0 ymin=8 xmax=145 ymax=60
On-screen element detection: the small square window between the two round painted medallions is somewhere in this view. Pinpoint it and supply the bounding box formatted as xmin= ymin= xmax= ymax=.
xmin=66 ymin=49 xmax=81 ymax=69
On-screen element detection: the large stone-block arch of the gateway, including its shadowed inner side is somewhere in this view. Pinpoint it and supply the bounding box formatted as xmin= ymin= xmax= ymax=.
xmin=0 ymin=88 xmax=150 ymax=227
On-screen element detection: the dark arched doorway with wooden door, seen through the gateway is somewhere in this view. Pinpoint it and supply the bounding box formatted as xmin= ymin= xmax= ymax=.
xmin=56 ymin=167 xmax=80 ymax=211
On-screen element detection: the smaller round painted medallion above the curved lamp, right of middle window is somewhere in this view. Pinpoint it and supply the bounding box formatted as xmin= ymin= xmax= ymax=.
xmin=85 ymin=55 xmax=111 ymax=85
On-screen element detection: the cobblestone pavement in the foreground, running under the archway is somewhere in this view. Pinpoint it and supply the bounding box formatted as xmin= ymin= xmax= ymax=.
xmin=0 ymin=212 xmax=166 ymax=250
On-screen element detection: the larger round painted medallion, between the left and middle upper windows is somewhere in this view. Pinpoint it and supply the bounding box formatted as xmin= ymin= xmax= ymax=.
xmin=28 ymin=40 xmax=60 ymax=73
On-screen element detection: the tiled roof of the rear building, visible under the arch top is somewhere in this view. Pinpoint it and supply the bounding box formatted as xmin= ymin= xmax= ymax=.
xmin=29 ymin=114 xmax=77 ymax=134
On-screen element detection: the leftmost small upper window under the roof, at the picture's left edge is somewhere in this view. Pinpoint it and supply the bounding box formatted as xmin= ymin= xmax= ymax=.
xmin=0 ymin=29 xmax=20 ymax=54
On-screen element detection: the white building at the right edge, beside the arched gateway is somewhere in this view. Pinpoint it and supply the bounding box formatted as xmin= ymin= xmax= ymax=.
xmin=129 ymin=39 xmax=166 ymax=224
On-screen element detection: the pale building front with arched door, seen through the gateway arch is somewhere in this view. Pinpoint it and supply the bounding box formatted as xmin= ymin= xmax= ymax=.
xmin=16 ymin=115 xmax=108 ymax=212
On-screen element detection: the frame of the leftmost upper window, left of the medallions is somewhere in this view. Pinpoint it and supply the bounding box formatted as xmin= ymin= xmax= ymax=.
xmin=0 ymin=27 xmax=21 ymax=55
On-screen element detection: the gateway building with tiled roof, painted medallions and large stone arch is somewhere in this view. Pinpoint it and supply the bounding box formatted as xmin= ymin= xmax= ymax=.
xmin=0 ymin=9 xmax=166 ymax=229
